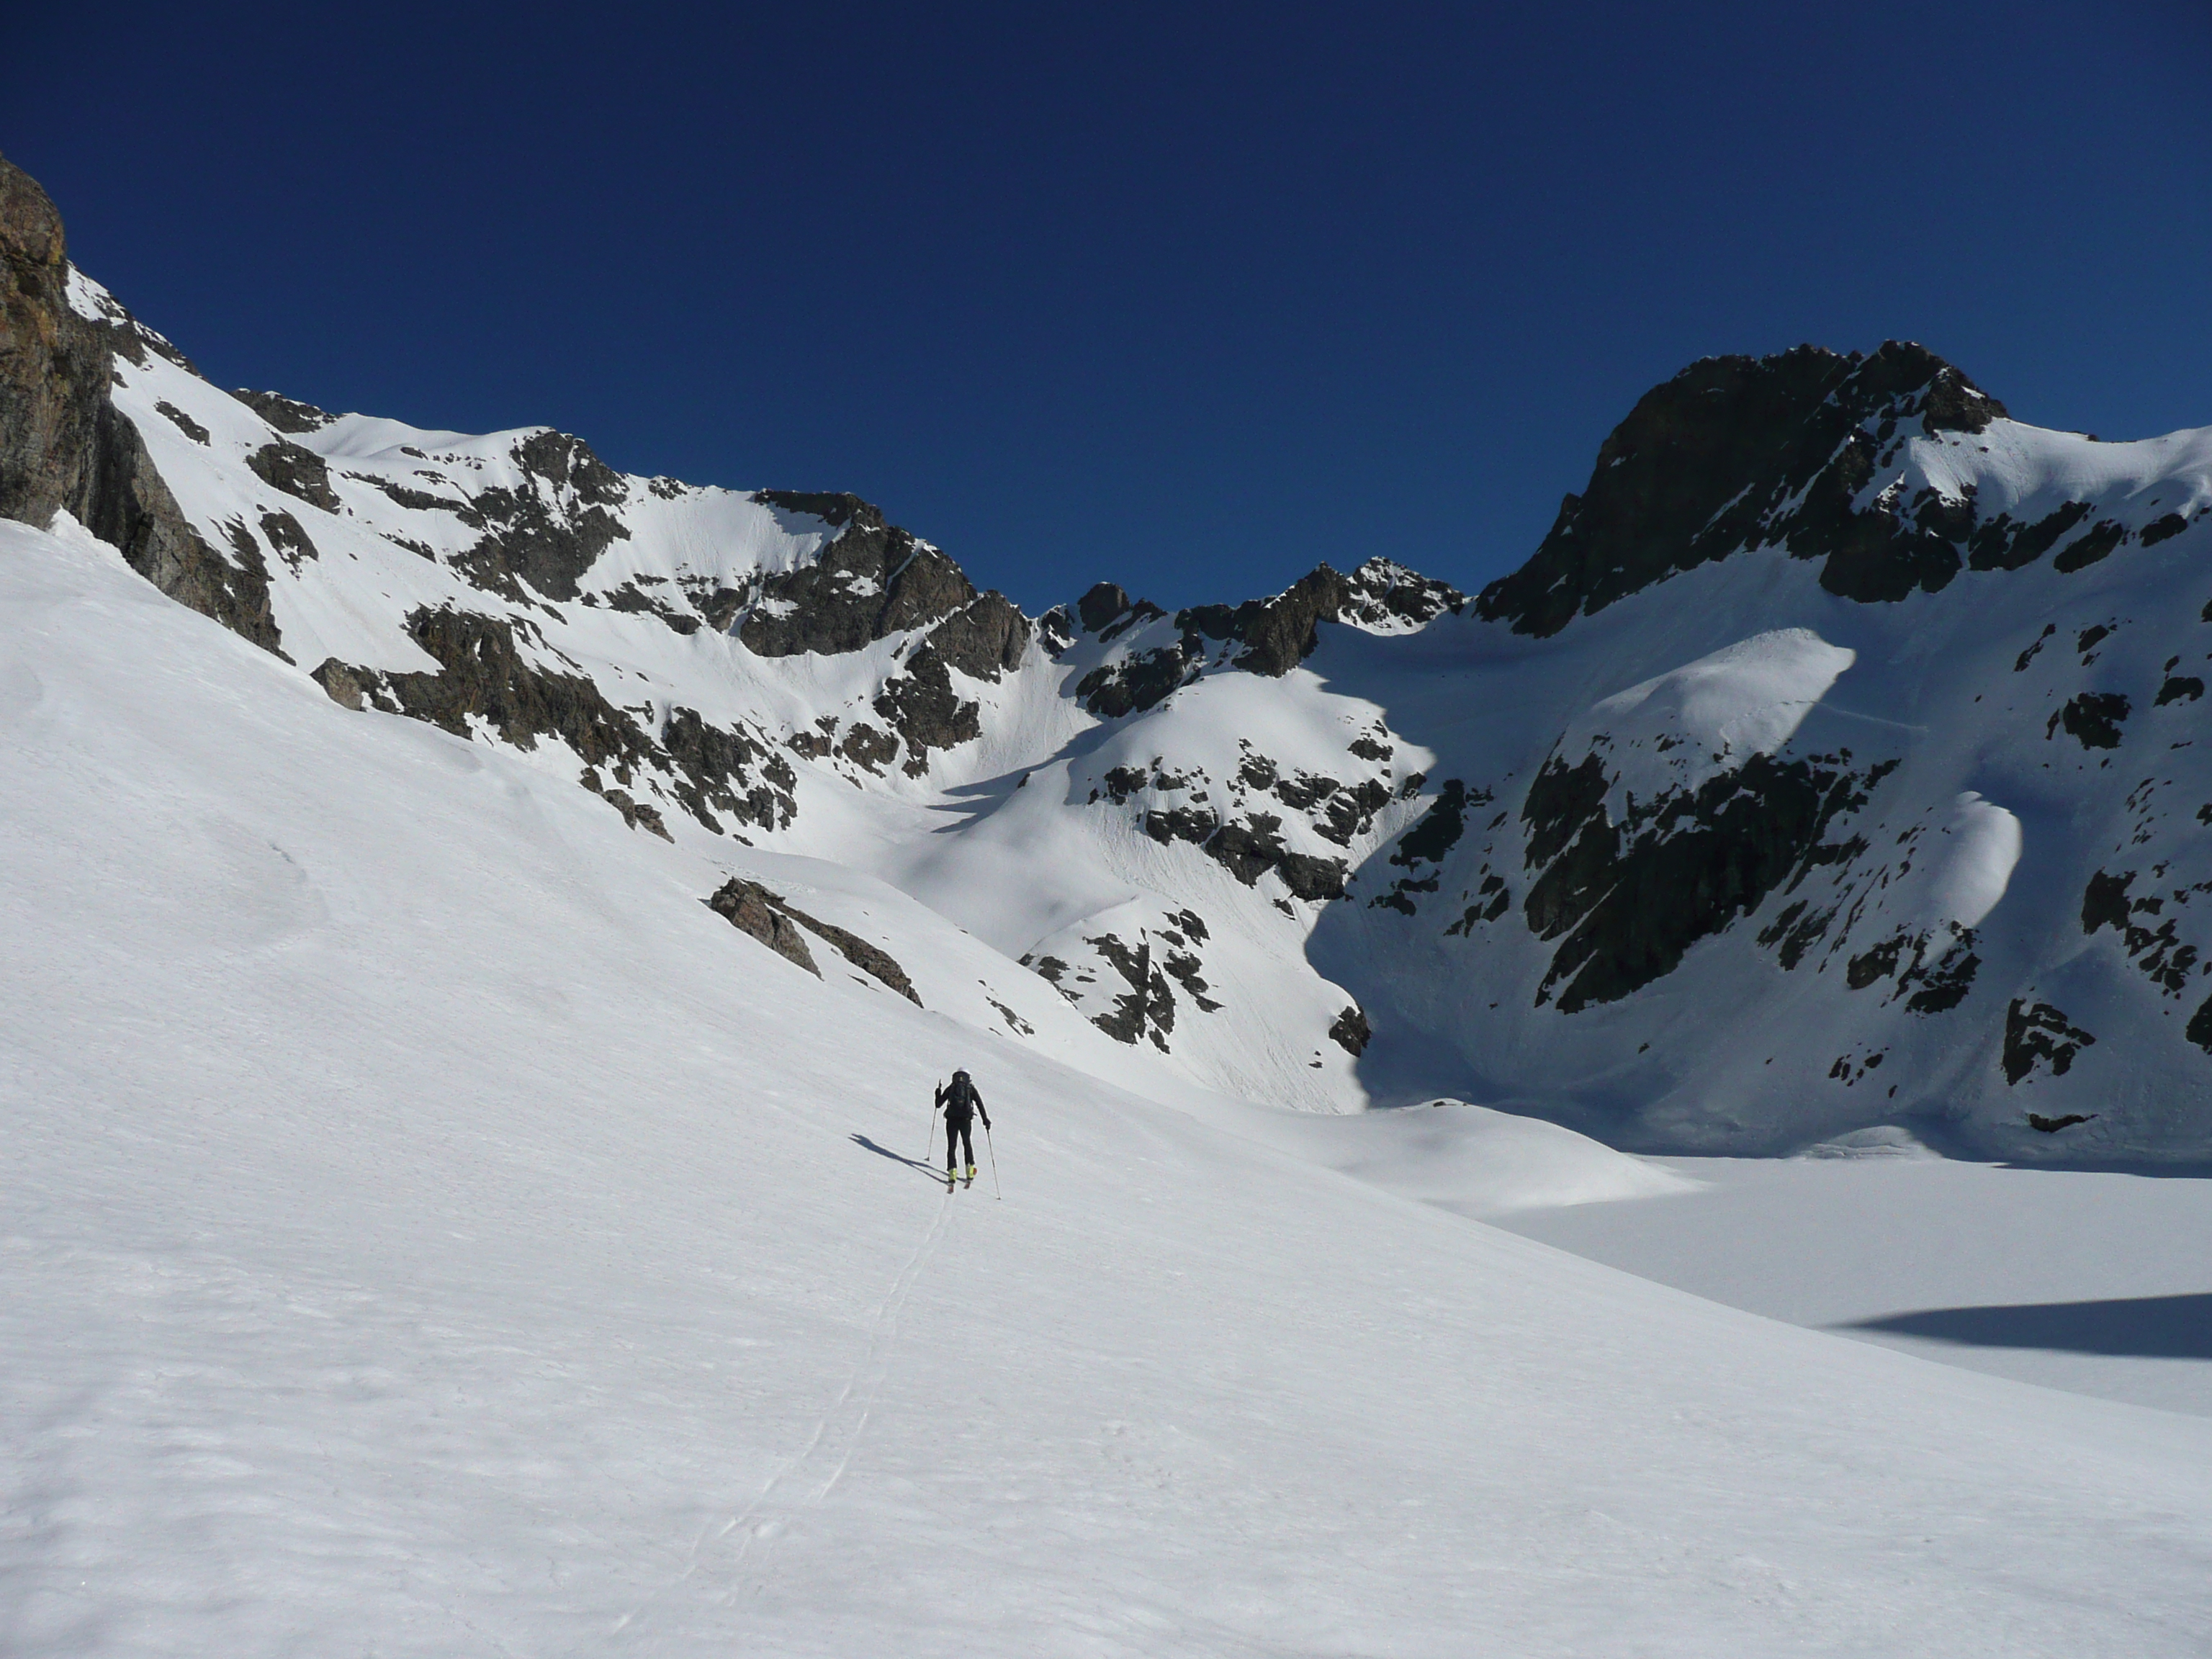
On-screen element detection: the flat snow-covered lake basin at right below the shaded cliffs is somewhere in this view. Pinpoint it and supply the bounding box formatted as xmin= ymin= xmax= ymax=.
xmin=1502 ymin=1137 xmax=2212 ymax=1418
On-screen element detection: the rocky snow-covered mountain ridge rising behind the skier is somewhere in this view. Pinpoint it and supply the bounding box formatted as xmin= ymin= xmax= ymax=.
xmin=0 ymin=166 xmax=2212 ymax=1161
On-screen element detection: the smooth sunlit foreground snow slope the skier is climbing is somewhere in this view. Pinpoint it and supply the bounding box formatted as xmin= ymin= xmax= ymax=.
xmin=0 ymin=522 xmax=2212 ymax=1659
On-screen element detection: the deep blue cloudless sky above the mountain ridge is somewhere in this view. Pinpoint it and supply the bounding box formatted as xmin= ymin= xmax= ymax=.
xmin=0 ymin=0 xmax=2212 ymax=608
